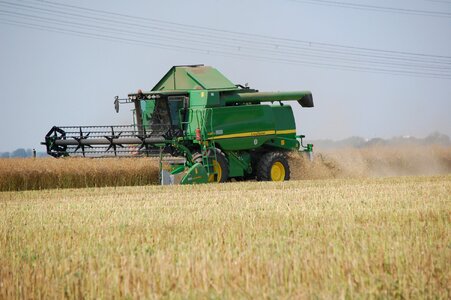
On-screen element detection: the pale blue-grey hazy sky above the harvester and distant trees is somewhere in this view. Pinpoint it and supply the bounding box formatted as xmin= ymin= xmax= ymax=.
xmin=0 ymin=0 xmax=451 ymax=152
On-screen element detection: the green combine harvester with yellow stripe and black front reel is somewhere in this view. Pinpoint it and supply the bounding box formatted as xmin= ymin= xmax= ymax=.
xmin=43 ymin=65 xmax=313 ymax=184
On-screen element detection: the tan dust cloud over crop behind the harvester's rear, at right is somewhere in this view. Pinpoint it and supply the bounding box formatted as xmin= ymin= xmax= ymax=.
xmin=290 ymin=145 xmax=451 ymax=180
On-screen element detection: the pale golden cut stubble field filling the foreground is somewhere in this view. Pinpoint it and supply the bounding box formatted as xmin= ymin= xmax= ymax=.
xmin=0 ymin=175 xmax=451 ymax=299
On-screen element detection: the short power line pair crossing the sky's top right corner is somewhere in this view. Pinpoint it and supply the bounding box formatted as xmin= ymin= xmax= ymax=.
xmin=288 ymin=0 xmax=451 ymax=18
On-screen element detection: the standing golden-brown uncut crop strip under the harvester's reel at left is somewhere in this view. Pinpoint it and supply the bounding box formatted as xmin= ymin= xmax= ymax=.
xmin=0 ymin=158 xmax=158 ymax=191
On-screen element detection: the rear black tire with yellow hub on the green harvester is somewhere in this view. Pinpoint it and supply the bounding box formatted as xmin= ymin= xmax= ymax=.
xmin=257 ymin=152 xmax=290 ymax=181
